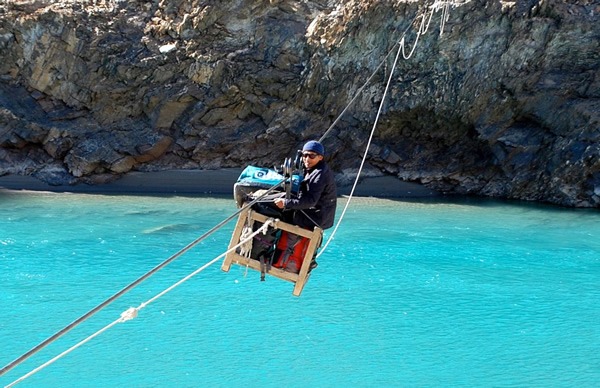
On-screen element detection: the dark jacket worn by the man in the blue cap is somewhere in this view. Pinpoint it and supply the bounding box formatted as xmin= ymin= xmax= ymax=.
xmin=285 ymin=160 xmax=337 ymax=229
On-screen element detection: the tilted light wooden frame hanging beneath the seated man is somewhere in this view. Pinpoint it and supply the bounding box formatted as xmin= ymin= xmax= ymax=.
xmin=221 ymin=209 xmax=323 ymax=296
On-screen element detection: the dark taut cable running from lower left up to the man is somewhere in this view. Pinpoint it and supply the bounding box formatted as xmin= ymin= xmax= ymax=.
xmin=0 ymin=179 xmax=285 ymax=376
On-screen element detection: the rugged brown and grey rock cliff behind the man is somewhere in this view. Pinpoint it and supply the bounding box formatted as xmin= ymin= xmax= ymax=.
xmin=0 ymin=0 xmax=600 ymax=207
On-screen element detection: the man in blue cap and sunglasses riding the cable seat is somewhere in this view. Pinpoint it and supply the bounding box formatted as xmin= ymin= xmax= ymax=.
xmin=274 ymin=140 xmax=337 ymax=229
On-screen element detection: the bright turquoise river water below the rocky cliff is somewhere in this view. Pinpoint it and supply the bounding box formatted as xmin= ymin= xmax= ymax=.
xmin=0 ymin=193 xmax=600 ymax=387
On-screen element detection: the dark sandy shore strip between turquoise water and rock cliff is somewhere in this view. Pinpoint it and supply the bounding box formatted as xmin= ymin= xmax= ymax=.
xmin=0 ymin=169 xmax=437 ymax=198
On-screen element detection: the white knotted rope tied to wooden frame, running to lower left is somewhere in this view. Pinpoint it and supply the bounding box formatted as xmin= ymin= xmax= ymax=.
xmin=6 ymin=218 xmax=275 ymax=388
